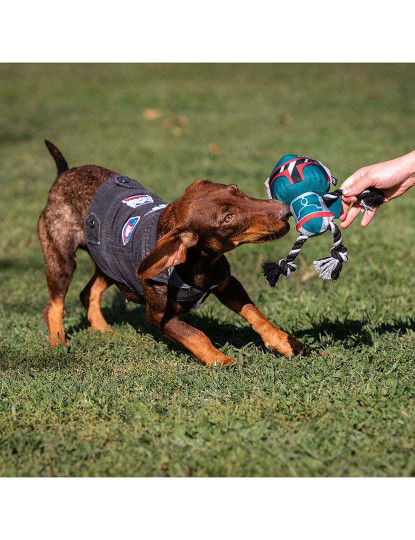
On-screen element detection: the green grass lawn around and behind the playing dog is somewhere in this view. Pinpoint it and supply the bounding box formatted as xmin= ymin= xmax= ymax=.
xmin=0 ymin=65 xmax=415 ymax=476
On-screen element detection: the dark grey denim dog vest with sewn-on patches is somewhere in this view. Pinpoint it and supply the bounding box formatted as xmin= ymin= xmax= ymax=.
xmin=85 ymin=175 xmax=230 ymax=309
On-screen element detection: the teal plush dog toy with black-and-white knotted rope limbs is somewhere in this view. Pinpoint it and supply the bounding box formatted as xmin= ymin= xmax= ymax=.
xmin=262 ymin=154 xmax=385 ymax=287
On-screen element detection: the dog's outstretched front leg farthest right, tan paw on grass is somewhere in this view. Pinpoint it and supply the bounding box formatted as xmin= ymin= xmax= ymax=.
xmin=214 ymin=276 xmax=305 ymax=356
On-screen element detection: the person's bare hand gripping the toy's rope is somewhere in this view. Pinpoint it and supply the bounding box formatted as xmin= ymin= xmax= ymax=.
xmin=340 ymin=151 xmax=415 ymax=229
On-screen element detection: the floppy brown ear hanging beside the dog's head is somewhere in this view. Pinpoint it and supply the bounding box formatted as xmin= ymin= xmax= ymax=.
xmin=137 ymin=227 xmax=198 ymax=278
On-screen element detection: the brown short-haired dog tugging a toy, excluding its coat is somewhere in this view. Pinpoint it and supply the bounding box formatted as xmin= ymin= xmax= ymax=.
xmin=38 ymin=141 xmax=304 ymax=365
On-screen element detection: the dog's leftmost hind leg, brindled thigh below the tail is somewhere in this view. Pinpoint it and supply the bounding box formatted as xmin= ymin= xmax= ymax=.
xmin=38 ymin=212 xmax=77 ymax=346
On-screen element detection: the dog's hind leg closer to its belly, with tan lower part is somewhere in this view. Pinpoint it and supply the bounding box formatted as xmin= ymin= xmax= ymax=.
xmin=80 ymin=266 xmax=113 ymax=332
